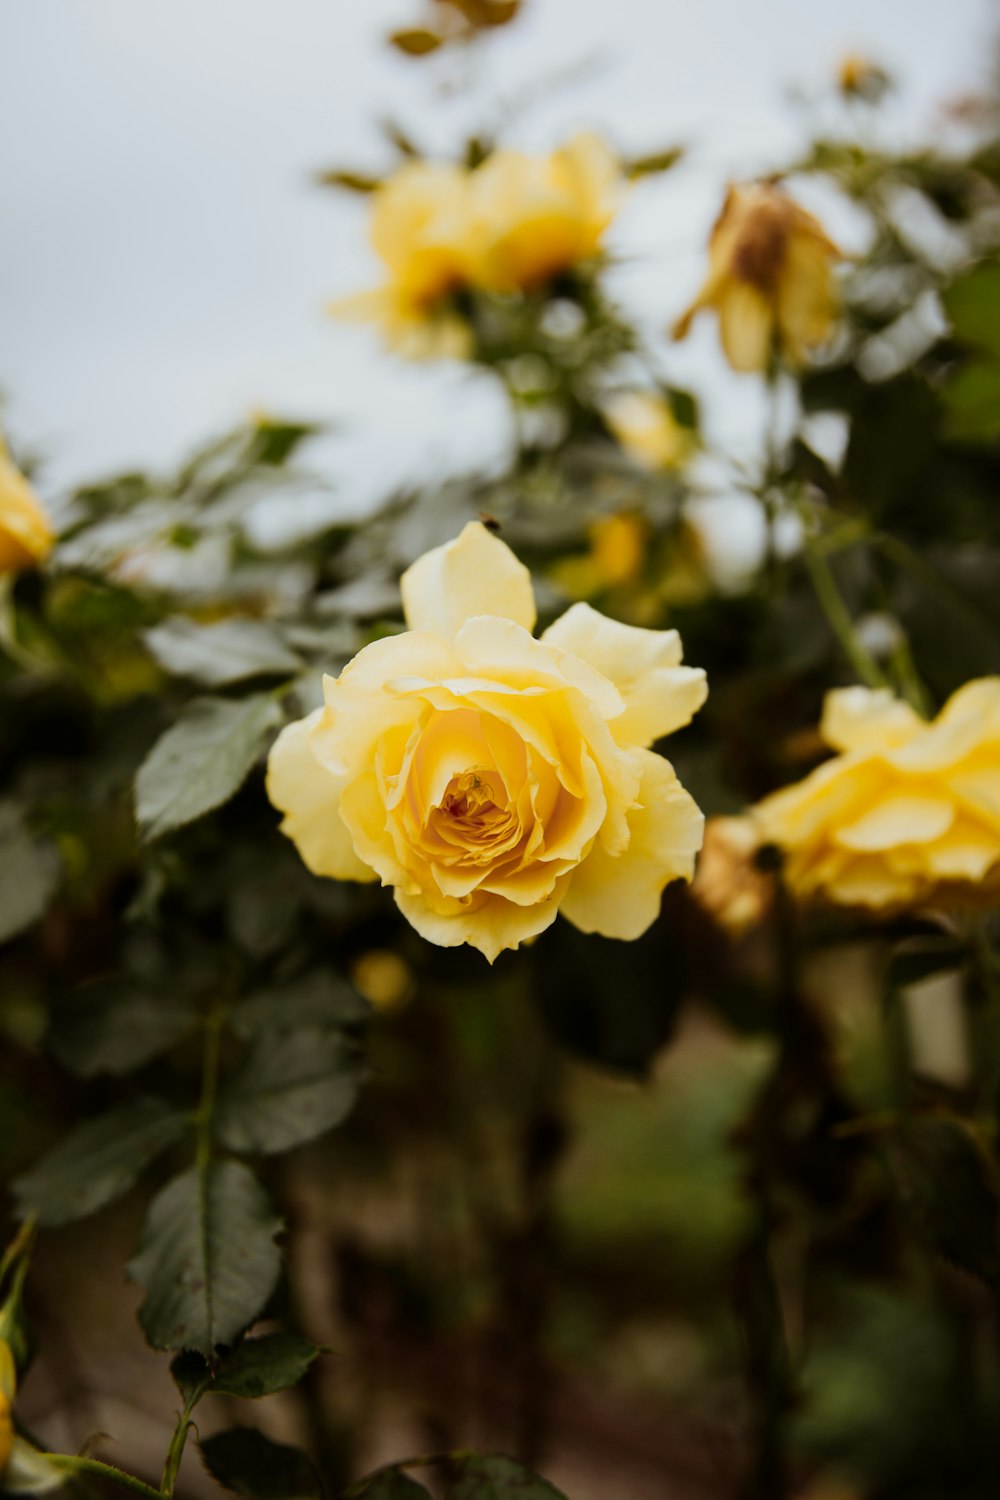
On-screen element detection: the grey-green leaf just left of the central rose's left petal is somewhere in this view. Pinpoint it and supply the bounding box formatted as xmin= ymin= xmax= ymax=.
xmin=135 ymin=695 xmax=282 ymax=839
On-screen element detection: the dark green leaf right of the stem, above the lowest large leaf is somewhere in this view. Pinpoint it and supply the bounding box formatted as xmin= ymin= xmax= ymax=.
xmin=216 ymin=1026 xmax=360 ymax=1152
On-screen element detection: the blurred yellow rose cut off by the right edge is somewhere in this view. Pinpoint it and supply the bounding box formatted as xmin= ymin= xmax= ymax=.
xmin=753 ymin=677 xmax=1000 ymax=909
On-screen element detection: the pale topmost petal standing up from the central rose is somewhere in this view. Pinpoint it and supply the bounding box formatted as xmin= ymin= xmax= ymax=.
xmin=399 ymin=521 xmax=535 ymax=639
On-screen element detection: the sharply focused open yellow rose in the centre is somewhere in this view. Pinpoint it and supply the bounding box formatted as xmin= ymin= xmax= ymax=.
xmin=267 ymin=522 xmax=706 ymax=962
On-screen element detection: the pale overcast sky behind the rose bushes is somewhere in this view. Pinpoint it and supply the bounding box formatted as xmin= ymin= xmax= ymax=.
xmin=0 ymin=0 xmax=999 ymax=510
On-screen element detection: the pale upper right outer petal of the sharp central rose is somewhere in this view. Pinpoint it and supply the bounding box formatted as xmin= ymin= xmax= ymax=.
xmin=541 ymin=603 xmax=708 ymax=746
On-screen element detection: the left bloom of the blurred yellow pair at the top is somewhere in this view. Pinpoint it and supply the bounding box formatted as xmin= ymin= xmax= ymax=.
xmin=330 ymin=162 xmax=471 ymax=359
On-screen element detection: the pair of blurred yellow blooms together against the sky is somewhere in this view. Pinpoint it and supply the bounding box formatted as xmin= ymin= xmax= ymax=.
xmin=330 ymin=134 xmax=622 ymax=357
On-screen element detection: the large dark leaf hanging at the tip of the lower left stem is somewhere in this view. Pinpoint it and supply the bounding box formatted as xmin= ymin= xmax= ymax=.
xmin=127 ymin=1161 xmax=282 ymax=1356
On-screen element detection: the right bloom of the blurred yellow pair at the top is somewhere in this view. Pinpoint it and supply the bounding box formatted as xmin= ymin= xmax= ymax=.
xmin=469 ymin=134 xmax=622 ymax=293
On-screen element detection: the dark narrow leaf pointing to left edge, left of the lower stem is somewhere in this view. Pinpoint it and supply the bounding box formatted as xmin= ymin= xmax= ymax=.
xmin=13 ymin=1098 xmax=186 ymax=1226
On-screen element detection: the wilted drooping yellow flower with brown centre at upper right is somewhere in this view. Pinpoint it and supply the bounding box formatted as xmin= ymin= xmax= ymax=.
xmin=673 ymin=182 xmax=841 ymax=371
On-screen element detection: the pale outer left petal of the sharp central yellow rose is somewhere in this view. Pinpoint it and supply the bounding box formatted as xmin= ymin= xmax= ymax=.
xmin=267 ymin=708 xmax=375 ymax=881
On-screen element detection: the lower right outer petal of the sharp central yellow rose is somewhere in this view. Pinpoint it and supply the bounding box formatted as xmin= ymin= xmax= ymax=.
xmin=562 ymin=750 xmax=705 ymax=939
